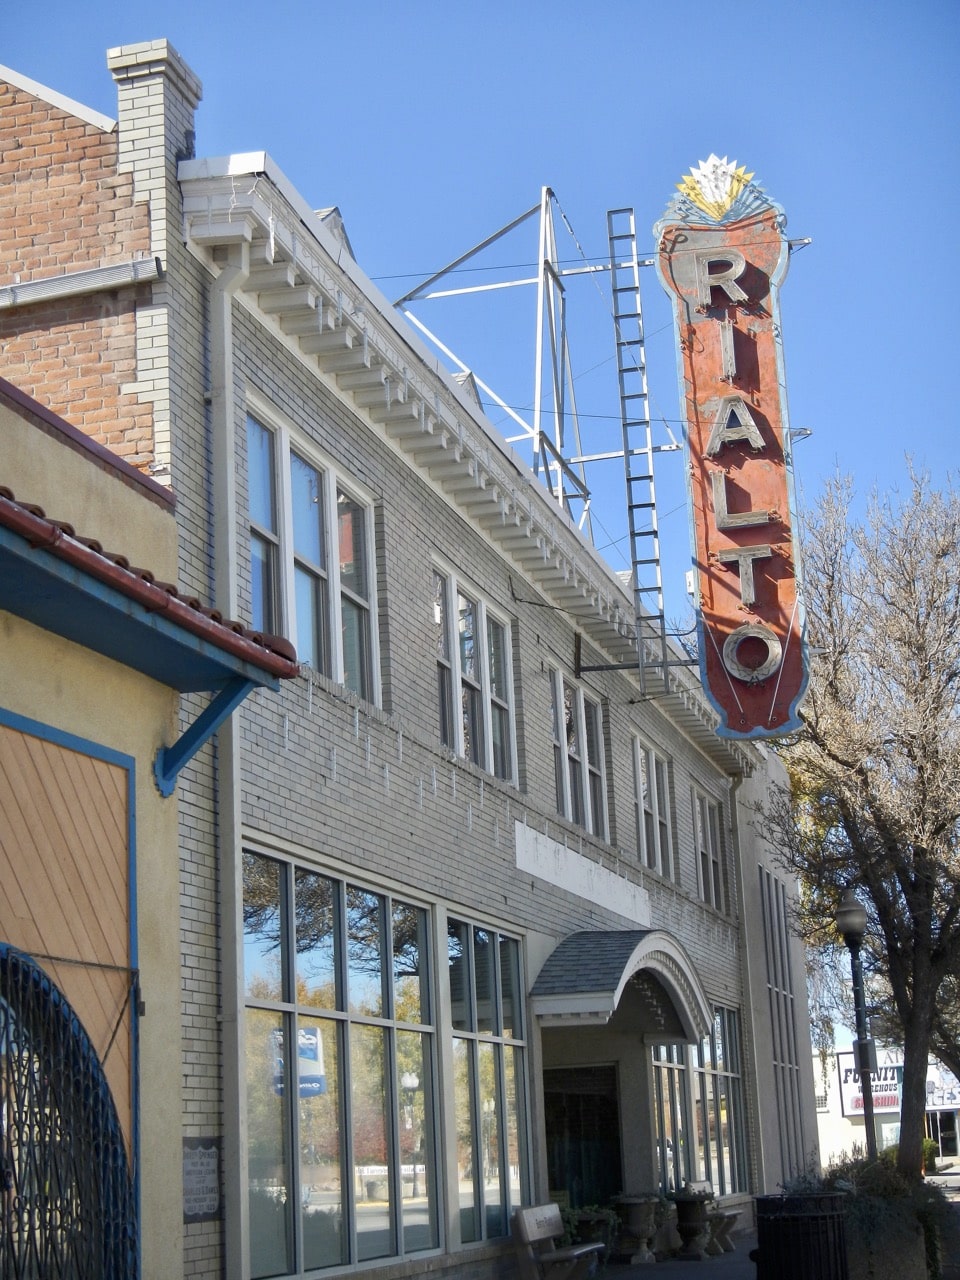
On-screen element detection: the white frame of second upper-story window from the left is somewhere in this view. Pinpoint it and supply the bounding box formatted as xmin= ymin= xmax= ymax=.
xmin=431 ymin=561 xmax=517 ymax=783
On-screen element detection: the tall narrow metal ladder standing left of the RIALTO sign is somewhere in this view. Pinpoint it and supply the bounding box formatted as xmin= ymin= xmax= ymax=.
xmin=607 ymin=209 xmax=667 ymax=694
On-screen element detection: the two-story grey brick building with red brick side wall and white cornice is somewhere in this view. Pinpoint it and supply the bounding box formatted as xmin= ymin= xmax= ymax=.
xmin=0 ymin=41 xmax=815 ymax=1277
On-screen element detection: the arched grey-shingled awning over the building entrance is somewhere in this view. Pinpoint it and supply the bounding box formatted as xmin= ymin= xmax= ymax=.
xmin=530 ymin=929 xmax=713 ymax=1043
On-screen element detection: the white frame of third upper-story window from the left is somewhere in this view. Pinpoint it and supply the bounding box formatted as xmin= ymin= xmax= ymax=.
xmin=549 ymin=667 xmax=608 ymax=840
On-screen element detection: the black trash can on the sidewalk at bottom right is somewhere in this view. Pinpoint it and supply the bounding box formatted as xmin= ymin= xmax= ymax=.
xmin=756 ymin=1192 xmax=849 ymax=1280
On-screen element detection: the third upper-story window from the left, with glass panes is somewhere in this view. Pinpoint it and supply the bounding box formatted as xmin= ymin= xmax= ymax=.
xmin=550 ymin=671 xmax=607 ymax=838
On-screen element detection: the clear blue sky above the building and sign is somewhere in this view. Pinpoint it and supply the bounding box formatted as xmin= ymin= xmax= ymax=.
xmin=0 ymin=0 xmax=960 ymax=617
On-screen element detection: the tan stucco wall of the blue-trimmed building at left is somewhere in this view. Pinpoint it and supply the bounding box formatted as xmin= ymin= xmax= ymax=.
xmin=0 ymin=389 xmax=183 ymax=1280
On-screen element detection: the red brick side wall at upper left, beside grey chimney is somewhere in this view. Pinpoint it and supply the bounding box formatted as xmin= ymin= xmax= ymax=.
xmin=0 ymin=81 xmax=154 ymax=468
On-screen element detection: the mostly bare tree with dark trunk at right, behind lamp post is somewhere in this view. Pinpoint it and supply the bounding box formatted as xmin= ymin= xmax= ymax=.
xmin=763 ymin=472 xmax=960 ymax=1175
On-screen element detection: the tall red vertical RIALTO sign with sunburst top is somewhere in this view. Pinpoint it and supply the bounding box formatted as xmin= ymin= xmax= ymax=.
xmin=654 ymin=156 xmax=806 ymax=737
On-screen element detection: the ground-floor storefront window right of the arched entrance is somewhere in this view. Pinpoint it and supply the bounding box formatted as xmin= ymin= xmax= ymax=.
xmin=653 ymin=1009 xmax=749 ymax=1196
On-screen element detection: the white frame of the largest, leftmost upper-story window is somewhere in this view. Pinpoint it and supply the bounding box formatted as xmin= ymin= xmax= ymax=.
xmin=247 ymin=389 xmax=381 ymax=707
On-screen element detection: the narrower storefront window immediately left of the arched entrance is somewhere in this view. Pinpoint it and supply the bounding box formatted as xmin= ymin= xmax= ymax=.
xmin=447 ymin=920 xmax=527 ymax=1243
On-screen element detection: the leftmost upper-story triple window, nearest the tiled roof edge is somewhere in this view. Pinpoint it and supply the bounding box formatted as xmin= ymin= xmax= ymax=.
xmin=247 ymin=416 xmax=378 ymax=701
